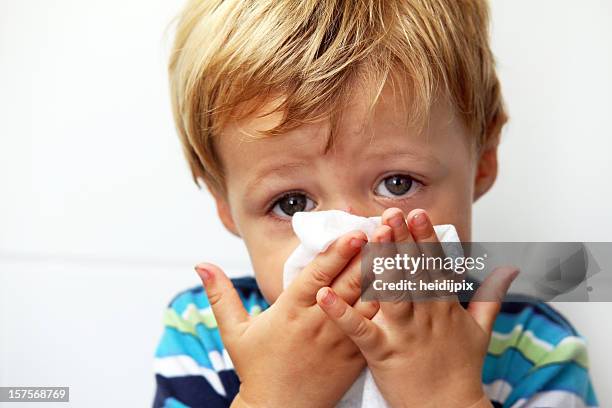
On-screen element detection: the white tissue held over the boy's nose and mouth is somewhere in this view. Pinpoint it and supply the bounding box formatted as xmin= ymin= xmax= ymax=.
xmin=283 ymin=210 xmax=462 ymax=408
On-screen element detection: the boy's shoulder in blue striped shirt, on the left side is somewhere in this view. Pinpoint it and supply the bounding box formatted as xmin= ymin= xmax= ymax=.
xmin=154 ymin=277 xmax=268 ymax=407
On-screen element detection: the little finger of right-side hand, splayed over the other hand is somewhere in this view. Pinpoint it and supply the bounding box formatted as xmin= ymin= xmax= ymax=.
xmin=317 ymin=287 xmax=380 ymax=355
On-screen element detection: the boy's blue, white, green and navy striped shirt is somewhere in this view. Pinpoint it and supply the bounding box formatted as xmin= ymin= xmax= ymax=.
xmin=153 ymin=277 xmax=598 ymax=408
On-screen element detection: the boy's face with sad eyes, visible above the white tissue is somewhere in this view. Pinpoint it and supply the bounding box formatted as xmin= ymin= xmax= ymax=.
xmin=215 ymin=77 xmax=497 ymax=302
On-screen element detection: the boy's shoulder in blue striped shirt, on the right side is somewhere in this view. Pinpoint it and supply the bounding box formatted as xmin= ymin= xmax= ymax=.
xmin=482 ymin=301 xmax=597 ymax=407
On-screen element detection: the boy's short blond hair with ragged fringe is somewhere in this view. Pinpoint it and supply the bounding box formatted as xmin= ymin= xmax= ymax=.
xmin=169 ymin=0 xmax=507 ymax=192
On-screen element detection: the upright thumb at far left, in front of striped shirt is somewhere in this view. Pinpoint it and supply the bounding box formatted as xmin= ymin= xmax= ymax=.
xmin=195 ymin=263 xmax=249 ymax=341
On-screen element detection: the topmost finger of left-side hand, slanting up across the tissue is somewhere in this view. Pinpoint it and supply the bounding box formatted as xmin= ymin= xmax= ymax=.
xmin=286 ymin=231 xmax=368 ymax=306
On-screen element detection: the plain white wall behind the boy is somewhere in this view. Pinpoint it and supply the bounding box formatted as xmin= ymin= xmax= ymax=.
xmin=0 ymin=0 xmax=612 ymax=407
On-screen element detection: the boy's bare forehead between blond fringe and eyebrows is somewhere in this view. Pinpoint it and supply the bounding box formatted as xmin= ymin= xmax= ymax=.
xmin=217 ymin=86 xmax=468 ymax=172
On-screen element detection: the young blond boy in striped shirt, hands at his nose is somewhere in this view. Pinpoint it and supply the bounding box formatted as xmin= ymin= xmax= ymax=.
xmin=154 ymin=0 xmax=597 ymax=407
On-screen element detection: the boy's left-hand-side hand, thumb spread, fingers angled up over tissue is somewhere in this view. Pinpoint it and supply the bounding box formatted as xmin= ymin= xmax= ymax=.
xmin=196 ymin=232 xmax=378 ymax=407
